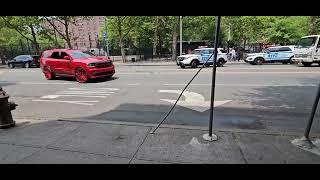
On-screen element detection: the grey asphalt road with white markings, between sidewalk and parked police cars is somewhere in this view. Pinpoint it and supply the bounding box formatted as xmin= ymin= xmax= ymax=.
xmin=0 ymin=63 xmax=320 ymax=133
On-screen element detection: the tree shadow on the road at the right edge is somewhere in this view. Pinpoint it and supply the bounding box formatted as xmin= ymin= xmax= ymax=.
xmin=233 ymin=83 xmax=320 ymax=132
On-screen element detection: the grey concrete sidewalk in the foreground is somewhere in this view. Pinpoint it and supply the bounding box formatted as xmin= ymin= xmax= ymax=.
xmin=0 ymin=120 xmax=320 ymax=164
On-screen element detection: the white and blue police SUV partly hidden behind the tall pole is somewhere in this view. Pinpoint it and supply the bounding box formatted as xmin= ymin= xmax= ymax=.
xmin=177 ymin=48 xmax=227 ymax=68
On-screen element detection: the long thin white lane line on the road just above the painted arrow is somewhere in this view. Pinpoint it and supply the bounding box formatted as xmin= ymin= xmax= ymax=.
xmin=163 ymin=84 xmax=317 ymax=87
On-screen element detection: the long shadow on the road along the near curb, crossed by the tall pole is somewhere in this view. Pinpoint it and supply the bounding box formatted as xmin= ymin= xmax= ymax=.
xmin=69 ymin=103 xmax=266 ymax=130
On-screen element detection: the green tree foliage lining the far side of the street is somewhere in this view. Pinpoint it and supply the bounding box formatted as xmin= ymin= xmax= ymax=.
xmin=0 ymin=16 xmax=320 ymax=61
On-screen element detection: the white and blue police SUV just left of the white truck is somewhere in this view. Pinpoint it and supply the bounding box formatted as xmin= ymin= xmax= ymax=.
xmin=245 ymin=46 xmax=294 ymax=65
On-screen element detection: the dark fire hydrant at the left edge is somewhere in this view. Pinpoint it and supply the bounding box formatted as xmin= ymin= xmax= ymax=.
xmin=0 ymin=87 xmax=18 ymax=129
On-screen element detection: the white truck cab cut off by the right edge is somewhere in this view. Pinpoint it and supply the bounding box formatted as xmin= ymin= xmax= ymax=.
xmin=292 ymin=35 xmax=320 ymax=66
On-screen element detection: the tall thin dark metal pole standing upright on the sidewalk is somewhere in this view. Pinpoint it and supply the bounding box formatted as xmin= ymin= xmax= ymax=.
xmin=209 ymin=16 xmax=221 ymax=137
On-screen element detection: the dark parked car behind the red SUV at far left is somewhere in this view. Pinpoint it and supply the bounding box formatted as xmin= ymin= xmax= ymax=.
xmin=7 ymin=55 xmax=40 ymax=69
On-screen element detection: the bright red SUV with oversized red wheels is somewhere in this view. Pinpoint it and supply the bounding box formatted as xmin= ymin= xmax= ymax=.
xmin=40 ymin=49 xmax=115 ymax=83
